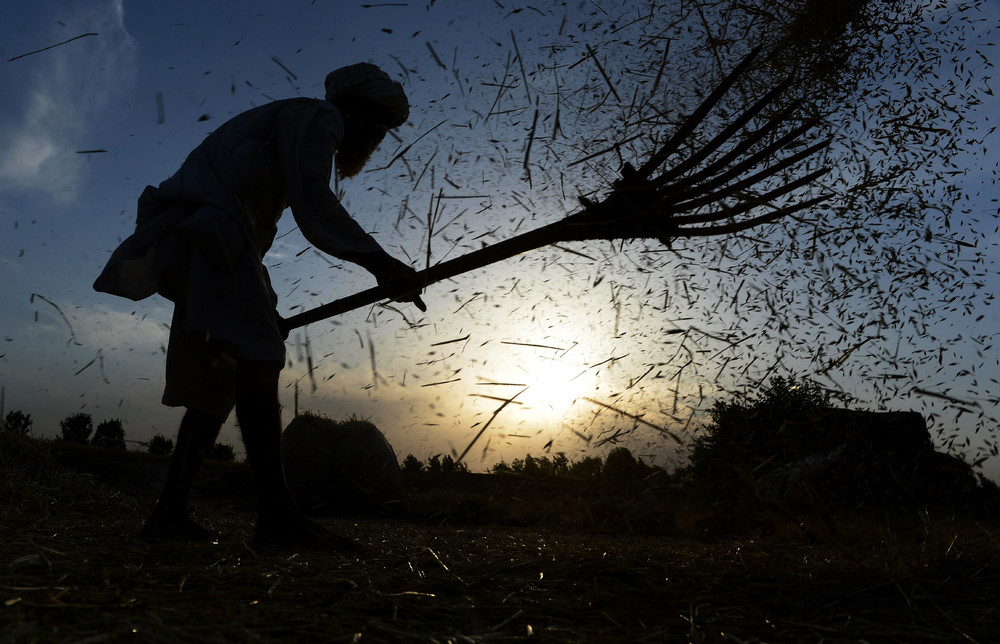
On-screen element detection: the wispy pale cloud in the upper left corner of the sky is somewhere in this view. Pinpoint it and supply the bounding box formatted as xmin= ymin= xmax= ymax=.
xmin=0 ymin=0 xmax=135 ymax=202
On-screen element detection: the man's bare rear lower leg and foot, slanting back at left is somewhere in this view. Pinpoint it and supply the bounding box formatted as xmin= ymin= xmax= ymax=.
xmin=141 ymin=409 xmax=222 ymax=541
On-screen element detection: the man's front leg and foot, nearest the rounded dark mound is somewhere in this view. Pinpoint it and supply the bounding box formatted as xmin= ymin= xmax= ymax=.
xmin=236 ymin=360 xmax=357 ymax=550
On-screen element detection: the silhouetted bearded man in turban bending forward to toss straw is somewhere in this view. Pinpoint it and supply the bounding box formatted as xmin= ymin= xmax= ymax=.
xmin=100 ymin=63 xmax=424 ymax=547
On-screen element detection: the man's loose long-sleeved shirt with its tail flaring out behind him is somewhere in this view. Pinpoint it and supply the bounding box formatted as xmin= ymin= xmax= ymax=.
xmin=94 ymin=98 xmax=385 ymax=300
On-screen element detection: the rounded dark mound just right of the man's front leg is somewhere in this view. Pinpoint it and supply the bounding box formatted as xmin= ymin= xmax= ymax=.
xmin=282 ymin=414 xmax=408 ymax=516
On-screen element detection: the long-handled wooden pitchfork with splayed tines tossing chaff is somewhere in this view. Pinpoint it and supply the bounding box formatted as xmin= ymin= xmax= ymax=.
xmin=284 ymin=47 xmax=830 ymax=330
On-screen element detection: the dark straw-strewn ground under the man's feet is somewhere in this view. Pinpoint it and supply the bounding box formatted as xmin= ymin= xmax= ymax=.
xmin=0 ymin=435 xmax=1000 ymax=643
